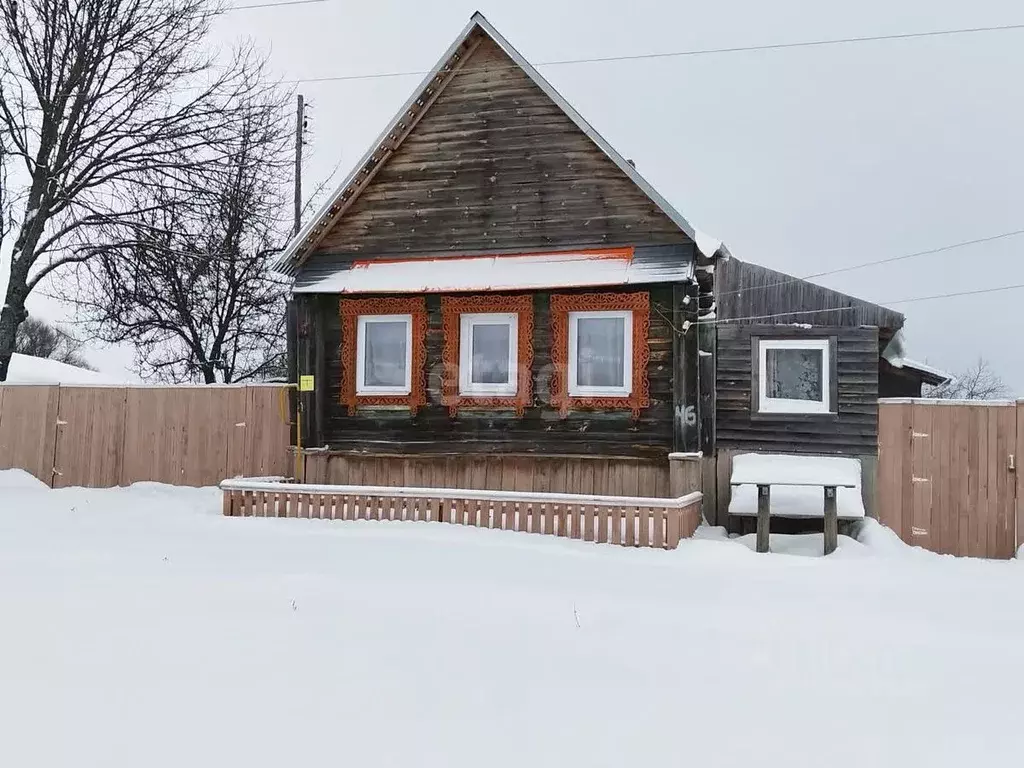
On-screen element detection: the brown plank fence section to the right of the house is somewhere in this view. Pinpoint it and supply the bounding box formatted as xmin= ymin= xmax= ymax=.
xmin=877 ymin=399 xmax=1024 ymax=558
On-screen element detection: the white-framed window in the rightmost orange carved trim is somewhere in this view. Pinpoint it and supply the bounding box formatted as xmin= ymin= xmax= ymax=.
xmin=568 ymin=311 xmax=633 ymax=397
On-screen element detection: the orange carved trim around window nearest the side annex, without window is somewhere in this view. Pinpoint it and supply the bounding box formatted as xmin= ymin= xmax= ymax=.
xmin=551 ymin=293 xmax=650 ymax=419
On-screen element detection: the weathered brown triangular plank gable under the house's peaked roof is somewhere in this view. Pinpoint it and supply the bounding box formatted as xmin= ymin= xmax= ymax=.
xmin=303 ymin=39 xmax=690 ymax=262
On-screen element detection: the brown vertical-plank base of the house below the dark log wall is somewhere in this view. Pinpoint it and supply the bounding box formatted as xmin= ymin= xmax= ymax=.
xmin=303 ymin=452 xmax=672 ymax=498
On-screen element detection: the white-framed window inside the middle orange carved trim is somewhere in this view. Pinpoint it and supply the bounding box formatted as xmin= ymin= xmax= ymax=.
xmin=459 ymin=312 xmax=519 ymax=395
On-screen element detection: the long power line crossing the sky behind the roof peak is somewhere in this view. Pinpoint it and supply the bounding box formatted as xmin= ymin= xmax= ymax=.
xmin=285 ymin=20 xmax=1024 ymax=83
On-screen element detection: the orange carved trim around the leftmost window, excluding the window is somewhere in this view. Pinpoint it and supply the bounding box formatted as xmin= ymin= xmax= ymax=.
xmin=339 ymin=298 xmax=427 ymax=415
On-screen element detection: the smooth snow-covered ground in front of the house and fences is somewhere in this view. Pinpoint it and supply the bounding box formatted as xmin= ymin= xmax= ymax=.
xmin=0 ymin=471 xmax=1024 ymax=768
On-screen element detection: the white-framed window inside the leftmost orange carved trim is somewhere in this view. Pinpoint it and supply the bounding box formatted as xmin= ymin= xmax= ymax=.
xmin=355 ymin=314 xmax=413 ymax=394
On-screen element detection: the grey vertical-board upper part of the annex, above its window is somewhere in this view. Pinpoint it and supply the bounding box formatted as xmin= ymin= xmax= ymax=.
xmin=715 ymin=258 xmax=903 ymax=331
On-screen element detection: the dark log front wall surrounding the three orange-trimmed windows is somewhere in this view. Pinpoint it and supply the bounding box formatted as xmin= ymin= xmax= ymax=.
xmin=295 ymin=285 xmax=673 ymax=459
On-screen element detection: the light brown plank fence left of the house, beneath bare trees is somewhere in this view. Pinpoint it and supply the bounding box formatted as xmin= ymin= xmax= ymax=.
xmin=0 ymin=384 xmax=294 ymax=487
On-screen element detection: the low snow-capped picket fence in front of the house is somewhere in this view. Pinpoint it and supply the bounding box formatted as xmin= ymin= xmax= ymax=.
xmin=220 ymin=479 xmax=701 ymax=549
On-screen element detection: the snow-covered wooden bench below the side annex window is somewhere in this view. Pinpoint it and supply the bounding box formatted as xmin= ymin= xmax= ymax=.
xmin=729 ymin=454 xmax=864 ymax=555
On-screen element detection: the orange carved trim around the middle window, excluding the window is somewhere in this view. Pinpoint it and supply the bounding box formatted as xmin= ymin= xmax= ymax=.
xmin=441 ymin=295 xmax=534 ymax=417
